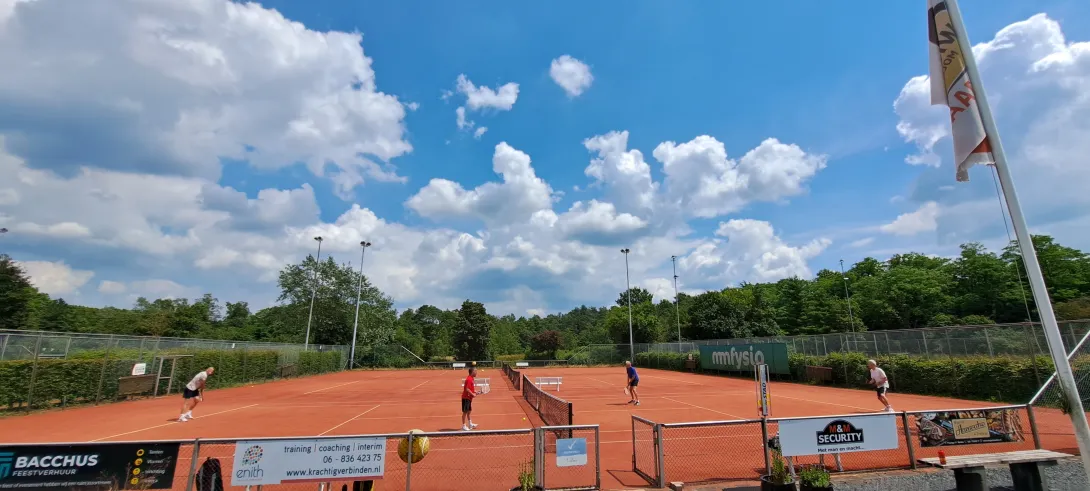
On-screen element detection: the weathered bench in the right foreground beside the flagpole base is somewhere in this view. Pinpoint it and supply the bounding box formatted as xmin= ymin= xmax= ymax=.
xmin=920 ymin=450 xmax=1071 ymax=491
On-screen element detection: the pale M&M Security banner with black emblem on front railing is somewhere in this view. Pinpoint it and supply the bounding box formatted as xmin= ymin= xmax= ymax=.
xmin=779 ymin=415 xmax=898 ymax=457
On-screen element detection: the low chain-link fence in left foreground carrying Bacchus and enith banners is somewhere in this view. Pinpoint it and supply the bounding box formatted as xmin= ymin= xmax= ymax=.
xmin=0 ymin=426 xmax=602 ymax=491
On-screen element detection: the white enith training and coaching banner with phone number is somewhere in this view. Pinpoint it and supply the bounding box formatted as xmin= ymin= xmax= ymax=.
xmin=231 ymin=438 xmax=386 ymax=486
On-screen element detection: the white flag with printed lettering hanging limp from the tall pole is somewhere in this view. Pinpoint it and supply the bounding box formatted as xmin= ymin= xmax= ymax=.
xmin=928 ymin=0 xmax=995 ymax=182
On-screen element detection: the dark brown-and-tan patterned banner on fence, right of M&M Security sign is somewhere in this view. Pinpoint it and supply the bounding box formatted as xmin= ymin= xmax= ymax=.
xmin=916 ymin=409 xmax=1024 ymax=446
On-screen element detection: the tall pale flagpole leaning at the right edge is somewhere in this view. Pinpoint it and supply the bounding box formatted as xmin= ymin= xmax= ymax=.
xmin=932 ymin=0 xmax=1090 ymax=469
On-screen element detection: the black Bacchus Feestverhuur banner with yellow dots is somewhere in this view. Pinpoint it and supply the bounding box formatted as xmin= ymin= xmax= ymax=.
xmin=0 ymin=443 xmax=180 ymax=489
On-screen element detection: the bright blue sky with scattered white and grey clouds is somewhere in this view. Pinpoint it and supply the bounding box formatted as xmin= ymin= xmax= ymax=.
xmin=0 ymin=0 xmax=1090 ymax=314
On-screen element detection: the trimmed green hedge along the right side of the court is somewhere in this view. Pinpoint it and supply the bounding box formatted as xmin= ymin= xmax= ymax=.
xmin=635 ymin=352 xmax=1072 ymax=404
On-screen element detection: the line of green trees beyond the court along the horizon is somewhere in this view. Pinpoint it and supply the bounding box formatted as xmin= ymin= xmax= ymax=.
xmin=0 ymin=236 xmax=1090 ymax=360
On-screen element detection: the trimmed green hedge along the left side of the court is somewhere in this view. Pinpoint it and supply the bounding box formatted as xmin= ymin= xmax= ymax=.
xmin=0 ymin=350 xmax=342 ymax=409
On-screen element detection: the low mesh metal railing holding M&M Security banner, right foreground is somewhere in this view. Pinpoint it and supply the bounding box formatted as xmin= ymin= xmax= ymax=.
xmin=632 ymin=405 xmax=1041 ymax=488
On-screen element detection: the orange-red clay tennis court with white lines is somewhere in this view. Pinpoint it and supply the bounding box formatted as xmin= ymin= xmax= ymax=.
xmin=0 ymin=368 xmax=1076 ymax=490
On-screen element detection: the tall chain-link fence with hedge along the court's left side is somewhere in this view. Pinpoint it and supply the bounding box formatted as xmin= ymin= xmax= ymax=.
xmin=0 ymin=331 xmax=348 ymax=409
